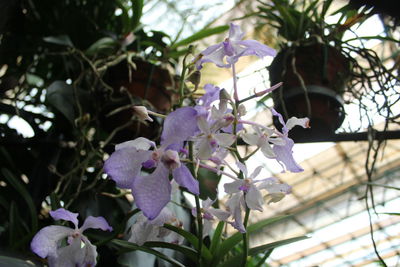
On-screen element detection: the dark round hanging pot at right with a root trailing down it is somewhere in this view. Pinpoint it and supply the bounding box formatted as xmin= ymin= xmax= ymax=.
xmin=269 ymin=44 xmax=349 ymax=141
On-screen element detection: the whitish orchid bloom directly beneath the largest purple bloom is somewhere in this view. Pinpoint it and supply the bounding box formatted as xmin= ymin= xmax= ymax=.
xmin=128 ymin=207 xmax=182 ymax=246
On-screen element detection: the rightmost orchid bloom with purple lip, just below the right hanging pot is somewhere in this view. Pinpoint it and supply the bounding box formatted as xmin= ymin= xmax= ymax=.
xmin=271 ymin=109 xmax=310 ymax=172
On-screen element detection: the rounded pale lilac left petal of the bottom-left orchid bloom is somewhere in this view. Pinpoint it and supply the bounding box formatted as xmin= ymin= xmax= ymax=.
xmin=31 ymin=225 xmax=74 ymax=258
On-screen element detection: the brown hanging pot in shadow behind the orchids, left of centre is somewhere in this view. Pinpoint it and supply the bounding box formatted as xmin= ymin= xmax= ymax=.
xmin=101 ymin=60 xmax=174 ymax=143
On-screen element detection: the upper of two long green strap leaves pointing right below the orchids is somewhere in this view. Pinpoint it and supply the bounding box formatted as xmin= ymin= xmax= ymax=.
xmin=214 ymin=215 xmax=290 ymax=262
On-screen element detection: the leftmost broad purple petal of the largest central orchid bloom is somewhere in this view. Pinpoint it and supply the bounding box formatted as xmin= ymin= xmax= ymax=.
xmin=104 ymin=148 xmax=152 ymax=188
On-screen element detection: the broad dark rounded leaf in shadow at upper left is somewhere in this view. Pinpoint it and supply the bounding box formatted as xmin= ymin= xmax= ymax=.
xmin=46 ymin=81 xmax=75 ymax=125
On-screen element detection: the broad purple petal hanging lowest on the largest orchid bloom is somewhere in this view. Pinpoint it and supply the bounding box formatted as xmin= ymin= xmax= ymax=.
xmin=132 ymin=164 xmax=171 ymax=220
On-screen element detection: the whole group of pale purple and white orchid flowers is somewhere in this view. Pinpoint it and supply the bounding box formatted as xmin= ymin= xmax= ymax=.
xmin=32 ymin=24 xmax=309 ymax=266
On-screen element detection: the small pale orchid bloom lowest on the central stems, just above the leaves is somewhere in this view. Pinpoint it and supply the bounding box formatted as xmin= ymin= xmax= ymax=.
xmin=192 ymin=198 xmax=231 ymax=237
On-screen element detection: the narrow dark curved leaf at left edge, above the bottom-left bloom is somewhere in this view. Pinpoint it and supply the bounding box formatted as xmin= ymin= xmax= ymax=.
xmin=1 ymin=168 xmax=38 ymax=233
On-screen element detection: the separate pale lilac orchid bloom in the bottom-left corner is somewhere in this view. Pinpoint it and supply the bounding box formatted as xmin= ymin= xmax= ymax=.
xmin=31 ymin=208 xmax=112 ymax=267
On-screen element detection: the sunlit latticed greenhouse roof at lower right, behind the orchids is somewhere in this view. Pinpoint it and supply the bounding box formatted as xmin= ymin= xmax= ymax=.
xmin=247 ymin=140 xmax=400 ymax=266
